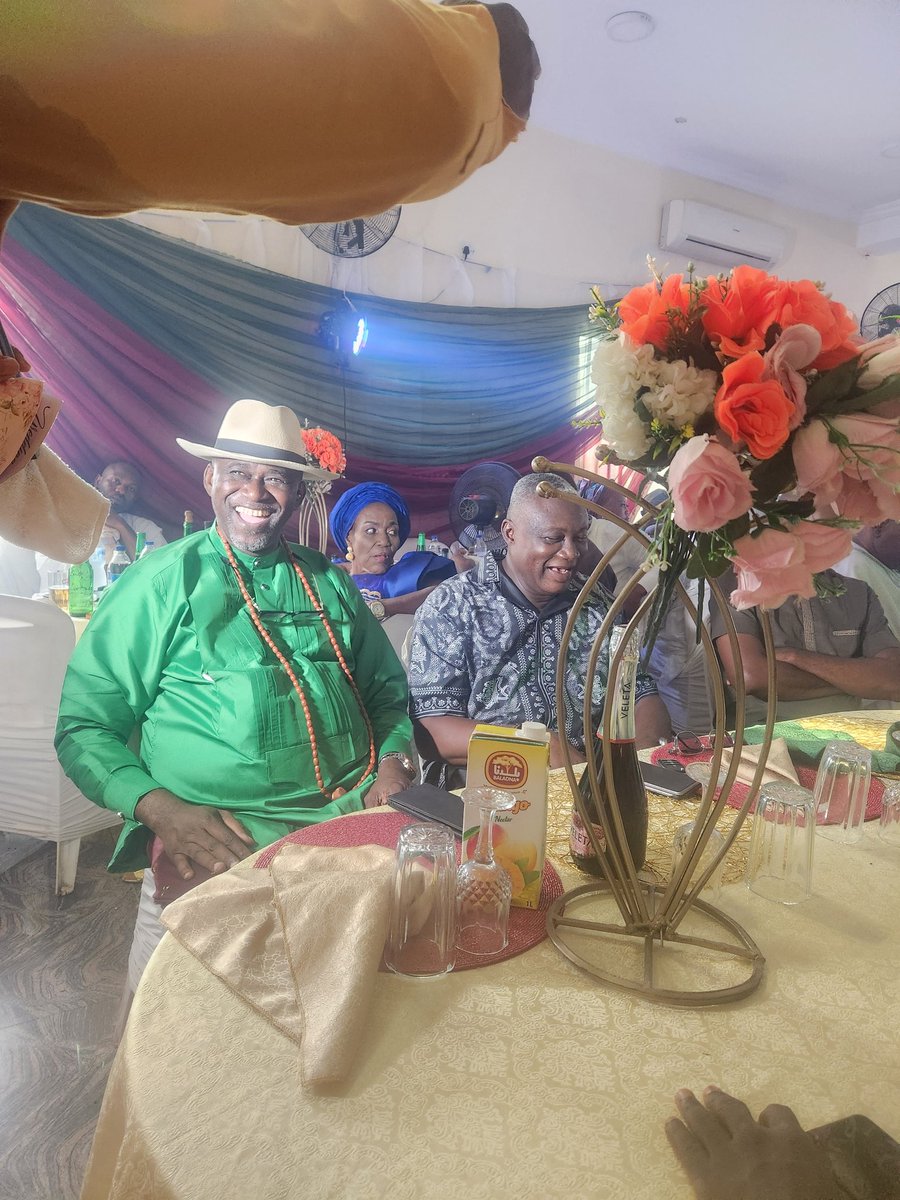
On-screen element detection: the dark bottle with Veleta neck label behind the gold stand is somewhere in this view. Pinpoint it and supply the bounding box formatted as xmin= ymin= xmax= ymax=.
xmin=569 ymin=625 xmax=647 ymax=875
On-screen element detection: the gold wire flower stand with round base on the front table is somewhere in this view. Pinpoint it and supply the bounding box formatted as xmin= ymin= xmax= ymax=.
xmin=532 ymin=458 xmax=775 ymax=1007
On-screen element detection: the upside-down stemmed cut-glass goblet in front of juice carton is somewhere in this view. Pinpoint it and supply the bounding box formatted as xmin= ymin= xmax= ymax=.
xmin=456 ymin=787 xmax=516 ymax=954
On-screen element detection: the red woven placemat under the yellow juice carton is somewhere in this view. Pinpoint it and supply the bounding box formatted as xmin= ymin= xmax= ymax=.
xmin=256 ymin=811 xmax=563 ymax=971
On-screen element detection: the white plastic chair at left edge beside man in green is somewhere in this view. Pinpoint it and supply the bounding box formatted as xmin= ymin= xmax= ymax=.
xmin=0 ymin=595 xmax=121 ymax=895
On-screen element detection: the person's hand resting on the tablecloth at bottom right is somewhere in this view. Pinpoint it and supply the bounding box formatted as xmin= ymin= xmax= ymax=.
xmin=666 ymin=1087 xmax=854 ymax=1200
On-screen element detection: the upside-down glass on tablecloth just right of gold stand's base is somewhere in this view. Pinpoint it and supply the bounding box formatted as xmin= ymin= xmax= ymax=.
xmin=746 ymin=782 xmax=816 ymax=905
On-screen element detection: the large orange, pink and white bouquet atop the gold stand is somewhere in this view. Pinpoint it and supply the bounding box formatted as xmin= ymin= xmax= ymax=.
xmin=590 ymin=263 xmax=900 ymax=631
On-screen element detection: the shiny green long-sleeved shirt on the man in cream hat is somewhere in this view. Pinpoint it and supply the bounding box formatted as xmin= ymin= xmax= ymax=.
xmin=56 ymin=530 xmax=412 ymax=870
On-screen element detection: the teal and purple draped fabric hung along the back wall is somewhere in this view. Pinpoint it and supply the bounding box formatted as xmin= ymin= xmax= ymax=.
xmin=0 ymin=205 xmax=607 ymax=533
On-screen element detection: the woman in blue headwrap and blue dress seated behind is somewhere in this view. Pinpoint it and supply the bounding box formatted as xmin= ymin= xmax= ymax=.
xmin=329 ymin=484 xmax=470 ymax=620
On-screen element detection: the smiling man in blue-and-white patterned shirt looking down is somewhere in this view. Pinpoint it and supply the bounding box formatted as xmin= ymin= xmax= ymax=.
xmin=408 ymin=474 xmax=671 ymax=787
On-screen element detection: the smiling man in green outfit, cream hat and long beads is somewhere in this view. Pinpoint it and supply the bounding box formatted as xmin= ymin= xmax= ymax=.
xmin=56 ymin=400 xmax=414 ymax=979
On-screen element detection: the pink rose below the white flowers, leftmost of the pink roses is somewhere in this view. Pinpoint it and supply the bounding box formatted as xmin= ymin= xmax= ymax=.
xmin=668 ymin=433 xmax=752 ymax=533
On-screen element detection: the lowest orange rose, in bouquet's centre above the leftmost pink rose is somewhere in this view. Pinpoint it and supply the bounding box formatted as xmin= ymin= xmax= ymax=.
xmin=713 ymin=354 xmax=794 ymax=458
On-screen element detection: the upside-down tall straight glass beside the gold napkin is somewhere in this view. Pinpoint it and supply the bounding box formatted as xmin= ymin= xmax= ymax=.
xmin=384 ymin=822 xmax=456 ymax=978
